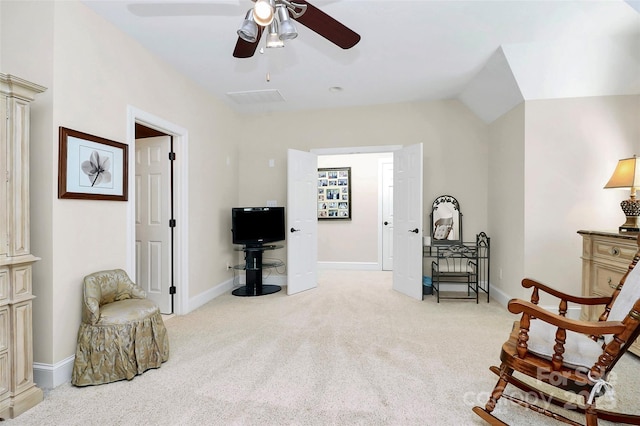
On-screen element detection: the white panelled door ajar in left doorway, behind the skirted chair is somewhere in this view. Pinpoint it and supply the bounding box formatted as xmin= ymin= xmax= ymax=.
xmin=135 ymin=136 xmax=172 ymax=313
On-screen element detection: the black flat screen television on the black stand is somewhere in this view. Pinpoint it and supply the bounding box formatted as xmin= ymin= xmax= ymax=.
xmin=231 ymin=207 xmax=285 ymax=246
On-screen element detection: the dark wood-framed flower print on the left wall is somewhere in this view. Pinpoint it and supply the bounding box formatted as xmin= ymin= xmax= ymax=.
xmin=58 ymin=127 xmax=128 ymax=201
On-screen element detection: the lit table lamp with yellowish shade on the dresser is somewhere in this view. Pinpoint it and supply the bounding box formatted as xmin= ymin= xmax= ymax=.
xmin=604 ymin=155 xmax=640 ymax=232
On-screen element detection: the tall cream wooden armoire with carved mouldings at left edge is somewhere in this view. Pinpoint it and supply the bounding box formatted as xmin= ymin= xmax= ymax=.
xmin=0 ymin=73 xmax=45 ymax=419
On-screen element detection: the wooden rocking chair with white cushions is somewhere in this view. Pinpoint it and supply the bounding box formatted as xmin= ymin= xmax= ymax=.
xmin=473 ymin=237 xmax=640 ymax=426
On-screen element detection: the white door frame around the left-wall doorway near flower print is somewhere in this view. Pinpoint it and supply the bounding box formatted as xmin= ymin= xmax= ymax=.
xmin=127 ymin=105 xmax=189 ymax=315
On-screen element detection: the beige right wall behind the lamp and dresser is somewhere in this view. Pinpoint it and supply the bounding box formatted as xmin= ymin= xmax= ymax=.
xmin=524 ymin=96 xmax=640 ymax=304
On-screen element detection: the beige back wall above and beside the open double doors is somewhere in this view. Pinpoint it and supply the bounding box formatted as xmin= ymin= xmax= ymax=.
xmin=239 ymin=100 xmax=488 ymax=243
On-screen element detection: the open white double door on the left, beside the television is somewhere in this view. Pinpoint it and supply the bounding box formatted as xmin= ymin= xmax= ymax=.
xmin=287 ymin=149 xmax=318 ymax=294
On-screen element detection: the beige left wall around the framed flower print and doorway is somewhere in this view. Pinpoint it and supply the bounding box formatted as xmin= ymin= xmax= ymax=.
xmin=2 ymin=1 xmax=238 ymax=364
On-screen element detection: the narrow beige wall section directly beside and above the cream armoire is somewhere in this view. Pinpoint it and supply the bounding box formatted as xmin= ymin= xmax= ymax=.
xmin=0 ymin=1 xmax=57 ymax=370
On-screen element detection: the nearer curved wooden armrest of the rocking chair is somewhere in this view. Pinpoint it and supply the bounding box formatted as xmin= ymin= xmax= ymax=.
xmin=508 ymin=299 xmax=625 ymax=336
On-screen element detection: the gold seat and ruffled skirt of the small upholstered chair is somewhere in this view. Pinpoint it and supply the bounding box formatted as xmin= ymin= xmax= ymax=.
xmin=71 ymin=299 xmax=169 ymax=386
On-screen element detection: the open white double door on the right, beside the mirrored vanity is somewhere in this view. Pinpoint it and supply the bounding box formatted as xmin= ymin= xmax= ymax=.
xmin=393 ymin=144 xmax=422 ymax=300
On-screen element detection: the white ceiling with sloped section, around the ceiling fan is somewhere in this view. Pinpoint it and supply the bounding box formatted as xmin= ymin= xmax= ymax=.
xmin=84 ymin=0 xmax=640 ymax=121
